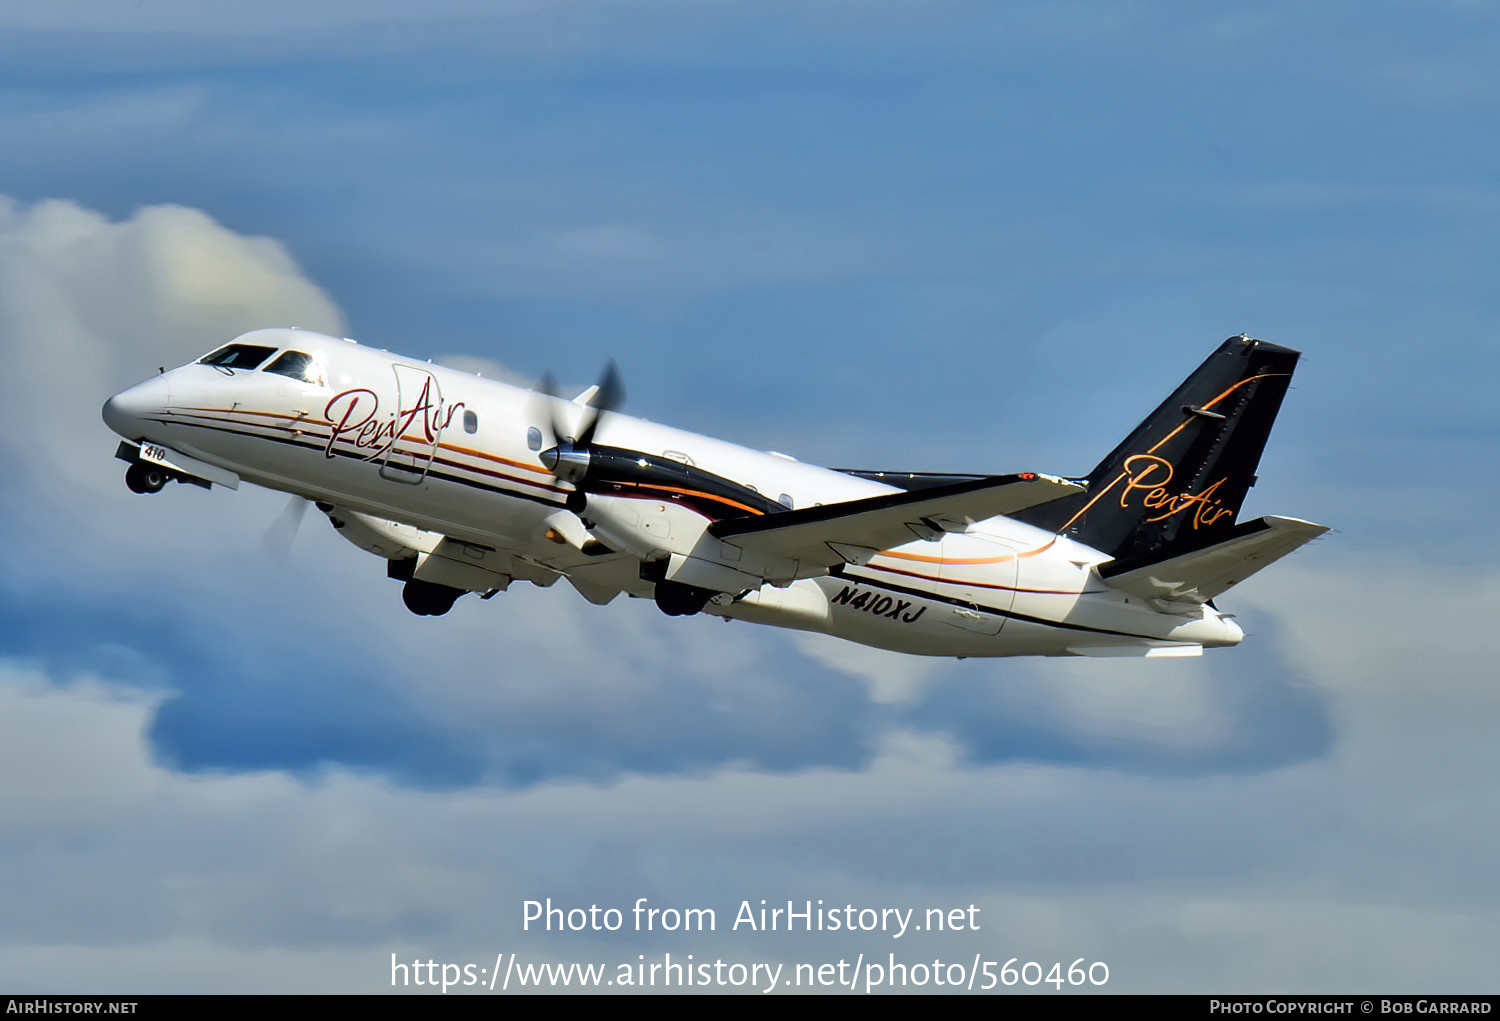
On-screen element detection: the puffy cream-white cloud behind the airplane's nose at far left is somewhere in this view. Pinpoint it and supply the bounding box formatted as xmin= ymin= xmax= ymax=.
xmin=0 ymin=196 xmax=342 ymax=498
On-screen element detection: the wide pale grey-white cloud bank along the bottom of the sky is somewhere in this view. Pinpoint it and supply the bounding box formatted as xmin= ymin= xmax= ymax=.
xmin=0 ymin=641 xmax=1497 ymax=993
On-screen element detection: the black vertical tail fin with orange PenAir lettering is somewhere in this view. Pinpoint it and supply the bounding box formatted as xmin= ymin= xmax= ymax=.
xmin=1016 ymin=337 xmax=1299 ymax=559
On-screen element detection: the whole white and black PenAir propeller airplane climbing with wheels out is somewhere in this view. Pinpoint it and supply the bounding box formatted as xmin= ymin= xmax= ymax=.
xmin=104 ymin=328 xmax=1328 ymax=658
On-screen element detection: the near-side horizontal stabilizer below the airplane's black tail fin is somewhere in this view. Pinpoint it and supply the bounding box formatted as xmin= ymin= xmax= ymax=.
xmin=1100 ymin=517 xmax=1328 ymax=603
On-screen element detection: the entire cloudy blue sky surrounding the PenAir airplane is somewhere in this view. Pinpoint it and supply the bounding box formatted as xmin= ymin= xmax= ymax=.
xmin=0 ymin=0 xmax=1500 ymax=993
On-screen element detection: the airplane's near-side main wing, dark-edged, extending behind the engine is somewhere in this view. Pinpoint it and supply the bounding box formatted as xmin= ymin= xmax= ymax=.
xmin=708 ymin=472 xmax=1083 ymax=568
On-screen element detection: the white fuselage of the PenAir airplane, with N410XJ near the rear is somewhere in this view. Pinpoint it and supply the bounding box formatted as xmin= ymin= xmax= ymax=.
xmin=96 ymin=330 xmax=1242 ymax=657
